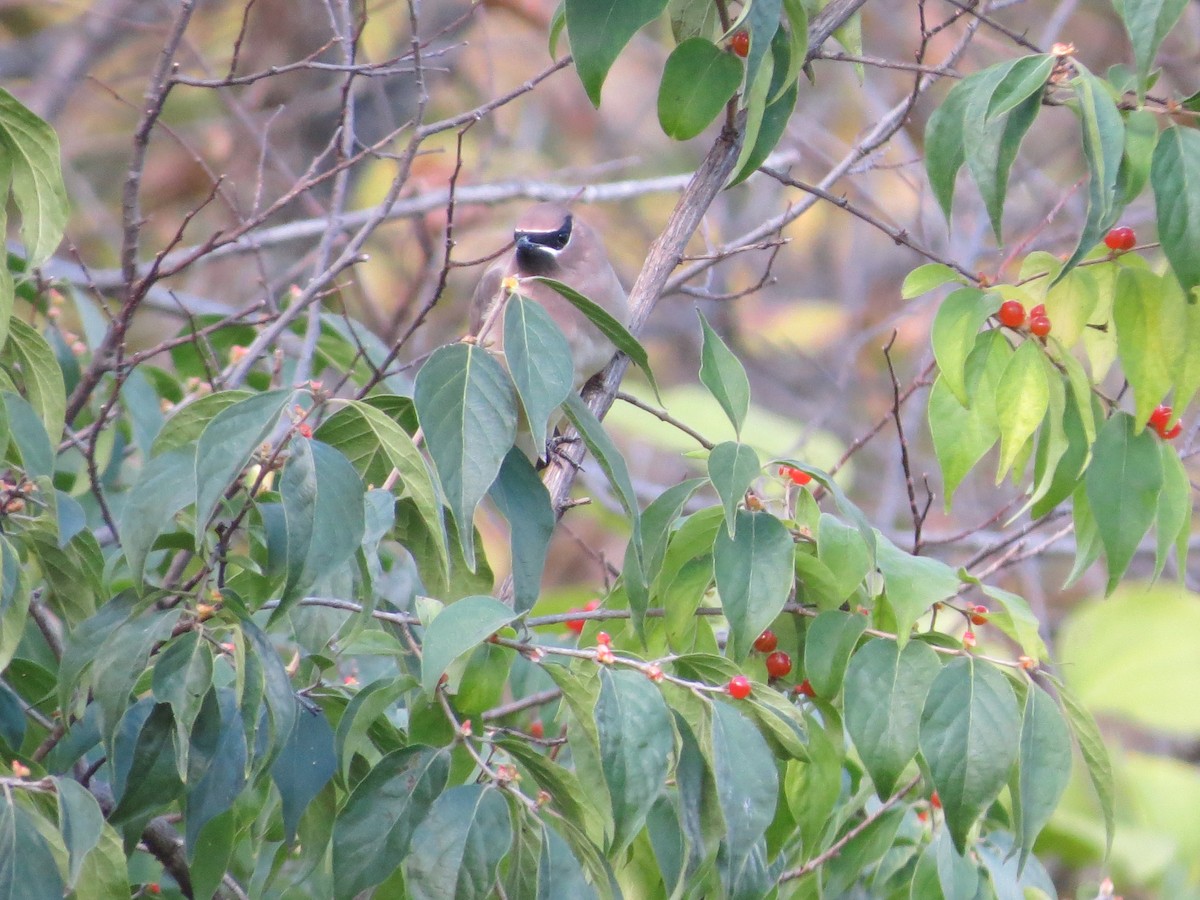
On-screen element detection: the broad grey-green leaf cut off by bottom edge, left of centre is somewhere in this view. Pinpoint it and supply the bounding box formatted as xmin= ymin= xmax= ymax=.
xmin=404 ymin=785 xmax=512 ymax=900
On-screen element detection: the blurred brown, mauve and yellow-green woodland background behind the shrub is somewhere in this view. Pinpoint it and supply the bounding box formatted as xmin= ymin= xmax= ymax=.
xmin=0 ymin=0 xmax=1200 ymax=898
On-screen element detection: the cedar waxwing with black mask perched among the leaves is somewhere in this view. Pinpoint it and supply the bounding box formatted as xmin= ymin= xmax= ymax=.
xmin=470 ymin=203 xmax=629 ymax=390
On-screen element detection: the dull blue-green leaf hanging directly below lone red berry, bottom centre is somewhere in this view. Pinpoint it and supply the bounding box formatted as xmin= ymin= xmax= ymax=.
xmin=712 ymin=702 xmax=779 ymax=878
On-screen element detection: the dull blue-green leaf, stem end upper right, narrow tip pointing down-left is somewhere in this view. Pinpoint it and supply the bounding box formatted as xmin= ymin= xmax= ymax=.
xmin=196 ymin=390 xmax=292 ymax=547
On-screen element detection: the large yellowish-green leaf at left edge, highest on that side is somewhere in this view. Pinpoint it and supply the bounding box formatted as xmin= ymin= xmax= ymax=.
xmin=0 ymin=89 xmax=70 ymax=267
